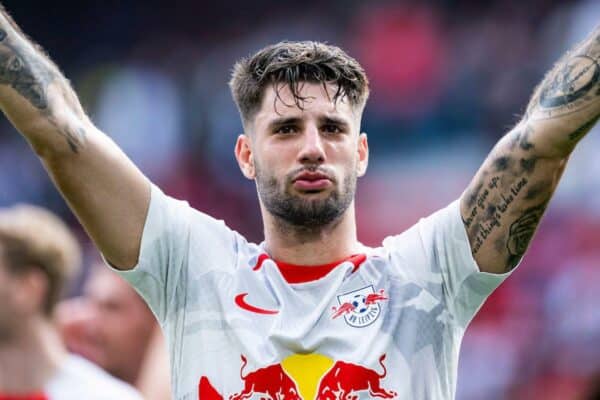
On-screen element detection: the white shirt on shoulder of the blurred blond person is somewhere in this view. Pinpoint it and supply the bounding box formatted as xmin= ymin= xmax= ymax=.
xmin=44 ymin=355 xmax=142 ymax=400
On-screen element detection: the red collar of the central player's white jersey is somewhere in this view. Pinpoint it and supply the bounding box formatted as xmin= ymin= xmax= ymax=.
xmin=252 ymin=253 xmax=367 ymax=284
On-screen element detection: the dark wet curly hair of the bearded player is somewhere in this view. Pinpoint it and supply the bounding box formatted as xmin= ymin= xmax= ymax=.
xmin=229 ymin=41 xmax=369 ymax=124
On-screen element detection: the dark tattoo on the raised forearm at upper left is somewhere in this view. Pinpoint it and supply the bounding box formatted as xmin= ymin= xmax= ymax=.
xmin=0 ymin=20 xmax=85 ymax=153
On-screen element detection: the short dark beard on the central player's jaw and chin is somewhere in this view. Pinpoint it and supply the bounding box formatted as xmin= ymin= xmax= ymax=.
xmin=256 ymin=166 xmax=357 ymax=232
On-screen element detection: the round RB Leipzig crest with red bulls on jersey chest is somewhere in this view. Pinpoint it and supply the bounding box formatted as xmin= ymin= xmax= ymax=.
xmin=331 ymin=286 xmax=388 ymax=328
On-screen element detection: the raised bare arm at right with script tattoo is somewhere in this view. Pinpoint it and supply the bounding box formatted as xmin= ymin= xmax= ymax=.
xmin=460 ymin=26 xmax=600 ymax=273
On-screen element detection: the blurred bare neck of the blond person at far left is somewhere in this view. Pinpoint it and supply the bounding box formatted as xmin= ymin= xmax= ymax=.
xmin=0 ymin=317 xmax=67 ymax=394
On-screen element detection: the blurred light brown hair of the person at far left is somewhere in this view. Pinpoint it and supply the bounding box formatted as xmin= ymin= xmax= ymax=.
xmin=0 ymin=205 xmax=81 ymax=315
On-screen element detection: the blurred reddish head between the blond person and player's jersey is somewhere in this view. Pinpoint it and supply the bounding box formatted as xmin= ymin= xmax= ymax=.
xmin=57 ymin=263 xmax=168 ymax=385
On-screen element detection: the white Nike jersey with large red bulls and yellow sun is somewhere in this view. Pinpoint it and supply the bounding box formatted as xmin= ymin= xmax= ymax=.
xmin=115 ymin=186 xmax=506 ymax=400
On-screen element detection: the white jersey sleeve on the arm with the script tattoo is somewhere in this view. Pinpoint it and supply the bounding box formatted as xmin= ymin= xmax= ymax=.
xmin=384 ymin=200 xmax=510 ymax=327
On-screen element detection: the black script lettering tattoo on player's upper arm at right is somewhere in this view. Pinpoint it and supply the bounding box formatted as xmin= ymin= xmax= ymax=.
xmin=462 ymin=125 xmax=557 ymax=271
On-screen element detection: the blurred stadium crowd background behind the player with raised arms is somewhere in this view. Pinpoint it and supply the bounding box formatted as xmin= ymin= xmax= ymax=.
xmin=0 ymin=0 xmax=600 ymax=400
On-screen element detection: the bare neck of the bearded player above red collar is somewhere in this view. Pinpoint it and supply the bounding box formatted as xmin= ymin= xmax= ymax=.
xmin=263 ymin=206 xmax=361 ymax=265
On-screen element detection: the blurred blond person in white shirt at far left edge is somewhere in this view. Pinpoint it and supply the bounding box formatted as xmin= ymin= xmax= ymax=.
xmin=0 ymin=205 xmax=141 ymax=400
